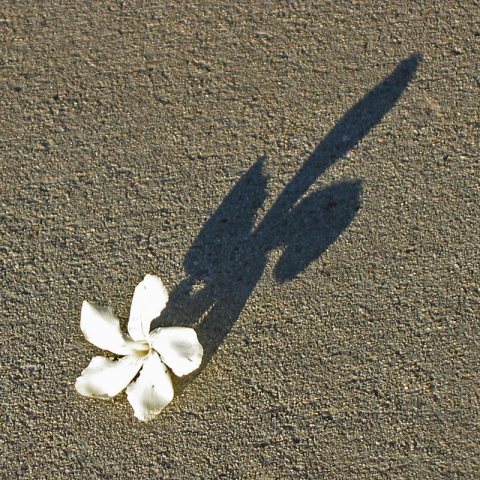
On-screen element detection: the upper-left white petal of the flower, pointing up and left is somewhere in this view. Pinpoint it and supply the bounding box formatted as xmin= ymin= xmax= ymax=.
xmin=80 ymin=300 xmax=142 ymax=355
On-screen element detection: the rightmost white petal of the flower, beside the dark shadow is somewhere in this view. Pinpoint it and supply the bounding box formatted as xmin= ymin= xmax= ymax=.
xmin=149 ymin=327 xmax=203 ymax=377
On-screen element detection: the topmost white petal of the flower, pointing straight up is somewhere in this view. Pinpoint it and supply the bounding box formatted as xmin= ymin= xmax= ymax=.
xmin=128 ymin=275 xmax=168 ymax=340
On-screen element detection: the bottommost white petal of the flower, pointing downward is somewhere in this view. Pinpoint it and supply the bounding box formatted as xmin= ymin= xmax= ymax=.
xmin=127 ymin=351 xmax=174 ymax=421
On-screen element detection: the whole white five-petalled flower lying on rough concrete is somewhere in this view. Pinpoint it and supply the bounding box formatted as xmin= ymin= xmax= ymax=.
xmin=75 ymin=275 xmax=203 ymax=421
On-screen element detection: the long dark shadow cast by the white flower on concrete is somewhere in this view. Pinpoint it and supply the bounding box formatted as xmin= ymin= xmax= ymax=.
xmin=152 ymin=55 xmax=421 ymax=392
